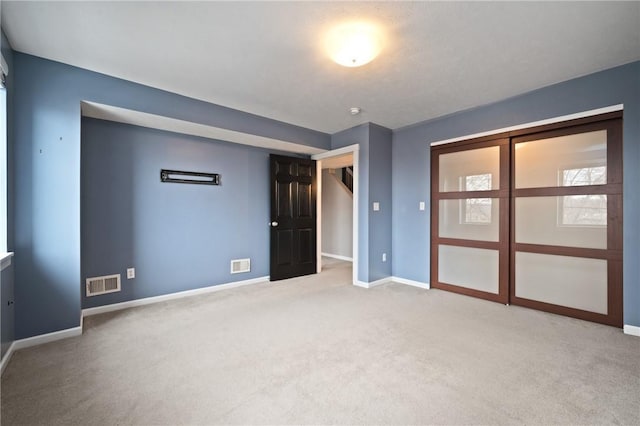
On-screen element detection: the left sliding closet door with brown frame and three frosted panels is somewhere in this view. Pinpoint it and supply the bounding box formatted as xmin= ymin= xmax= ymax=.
xmin=431 ymin=139 xmax=509 ymax=303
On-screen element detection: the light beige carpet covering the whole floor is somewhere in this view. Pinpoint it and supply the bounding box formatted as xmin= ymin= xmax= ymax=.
xmin=2 ymin=263 xmax=640 ymax=425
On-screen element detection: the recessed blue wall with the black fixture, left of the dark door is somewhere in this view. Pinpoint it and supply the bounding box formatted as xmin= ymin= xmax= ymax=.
xmin=81 ymin=118 xmax=270 ymax=308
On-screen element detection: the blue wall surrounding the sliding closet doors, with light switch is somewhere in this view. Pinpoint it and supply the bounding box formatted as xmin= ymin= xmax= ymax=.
xmin=393 ymin=62 xmax=640 ymax=326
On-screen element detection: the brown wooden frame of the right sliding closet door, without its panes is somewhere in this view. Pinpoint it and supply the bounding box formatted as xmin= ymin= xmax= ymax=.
xmin=509 ymin=114 xmax=623 ymax=327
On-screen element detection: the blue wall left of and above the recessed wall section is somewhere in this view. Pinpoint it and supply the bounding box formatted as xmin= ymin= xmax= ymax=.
xmin=14 ymin=52 xmax=331 ymax=338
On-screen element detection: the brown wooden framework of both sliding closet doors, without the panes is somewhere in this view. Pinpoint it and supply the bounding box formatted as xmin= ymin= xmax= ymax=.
xmin=430 ymin=111 xmax=623 ymax=327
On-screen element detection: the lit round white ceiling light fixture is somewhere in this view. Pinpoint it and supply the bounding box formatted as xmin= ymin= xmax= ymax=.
xmin=326 ymin=22 xmax=383 ymax=67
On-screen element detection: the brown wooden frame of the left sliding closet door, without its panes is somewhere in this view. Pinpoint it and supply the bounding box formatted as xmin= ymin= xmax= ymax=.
xmin=430 ymin=136 xmax=510 ymax=304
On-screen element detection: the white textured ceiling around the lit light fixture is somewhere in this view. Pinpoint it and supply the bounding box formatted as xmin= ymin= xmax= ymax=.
xmin=2 ymin=1 xmax=640 ymax=133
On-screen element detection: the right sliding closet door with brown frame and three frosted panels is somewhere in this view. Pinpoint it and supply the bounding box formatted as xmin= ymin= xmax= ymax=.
xmin=510 ymin=119 xmax=622 ymax=326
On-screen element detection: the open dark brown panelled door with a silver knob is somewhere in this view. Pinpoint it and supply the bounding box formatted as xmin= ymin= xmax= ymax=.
xmin=270 ymin=155 xmax=317 ymax=281
